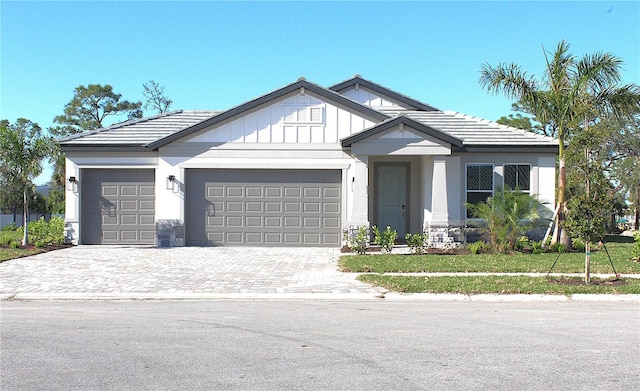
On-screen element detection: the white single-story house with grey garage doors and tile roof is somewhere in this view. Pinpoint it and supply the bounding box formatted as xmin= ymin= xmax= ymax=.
xmin=60 ymin=75 xmax=558 ymax=247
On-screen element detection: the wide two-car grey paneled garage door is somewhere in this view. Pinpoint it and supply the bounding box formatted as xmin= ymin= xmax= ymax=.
xmin=185 ymin=169 xmax=341 ymax=246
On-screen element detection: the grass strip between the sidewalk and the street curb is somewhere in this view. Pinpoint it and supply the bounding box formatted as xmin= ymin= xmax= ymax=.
xmin=358 ymin=274 xmax=640 ymax=295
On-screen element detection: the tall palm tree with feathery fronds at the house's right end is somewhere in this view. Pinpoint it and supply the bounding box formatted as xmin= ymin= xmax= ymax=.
xmin=480 ymin=41 xmax=640 ymax=248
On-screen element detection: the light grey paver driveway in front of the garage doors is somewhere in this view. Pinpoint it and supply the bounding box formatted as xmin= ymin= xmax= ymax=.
xmin=0 ymin=246 xmax=379 ymax=299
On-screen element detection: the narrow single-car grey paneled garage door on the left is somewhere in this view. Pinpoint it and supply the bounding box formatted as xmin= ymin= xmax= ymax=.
xmin=80 ymin=169 xmax=155 ymax=244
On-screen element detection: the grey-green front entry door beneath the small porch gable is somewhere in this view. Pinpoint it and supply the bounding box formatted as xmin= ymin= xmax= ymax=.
xmin=377 ymin=165 xmax=407 ymax=238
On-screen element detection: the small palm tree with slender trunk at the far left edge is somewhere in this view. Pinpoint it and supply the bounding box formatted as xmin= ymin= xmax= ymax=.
xmin=0 ymin=118 xmax=53 ymax=246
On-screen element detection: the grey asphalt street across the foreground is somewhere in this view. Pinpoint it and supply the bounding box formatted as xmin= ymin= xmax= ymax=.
xmin=0 ymin=300 xmax=640 ymax=390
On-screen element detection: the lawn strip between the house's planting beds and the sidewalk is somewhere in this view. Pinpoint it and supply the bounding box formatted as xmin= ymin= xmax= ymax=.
xmin=339 ymin=243 xmax=640 ymax=274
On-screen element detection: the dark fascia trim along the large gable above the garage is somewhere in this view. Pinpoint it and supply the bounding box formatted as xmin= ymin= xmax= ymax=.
xmin=146 ymin=78 xmax=389 ymax=149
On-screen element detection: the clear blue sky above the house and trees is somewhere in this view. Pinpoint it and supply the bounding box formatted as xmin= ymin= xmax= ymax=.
xmin=0 ymin=0 xmax=640 ymax=184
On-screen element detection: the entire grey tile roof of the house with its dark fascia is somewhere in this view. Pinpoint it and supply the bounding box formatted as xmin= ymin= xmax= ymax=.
xmin=59 ymin=77 xmax=558 ymax=150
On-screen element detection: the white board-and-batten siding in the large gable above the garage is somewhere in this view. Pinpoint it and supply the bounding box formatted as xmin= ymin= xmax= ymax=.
xmin=186 ymin=93 xmax=374 ymax=145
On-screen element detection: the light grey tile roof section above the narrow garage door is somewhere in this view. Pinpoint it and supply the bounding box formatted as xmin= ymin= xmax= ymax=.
xmin=58 ymin=110 xmax=220 ymax=149
